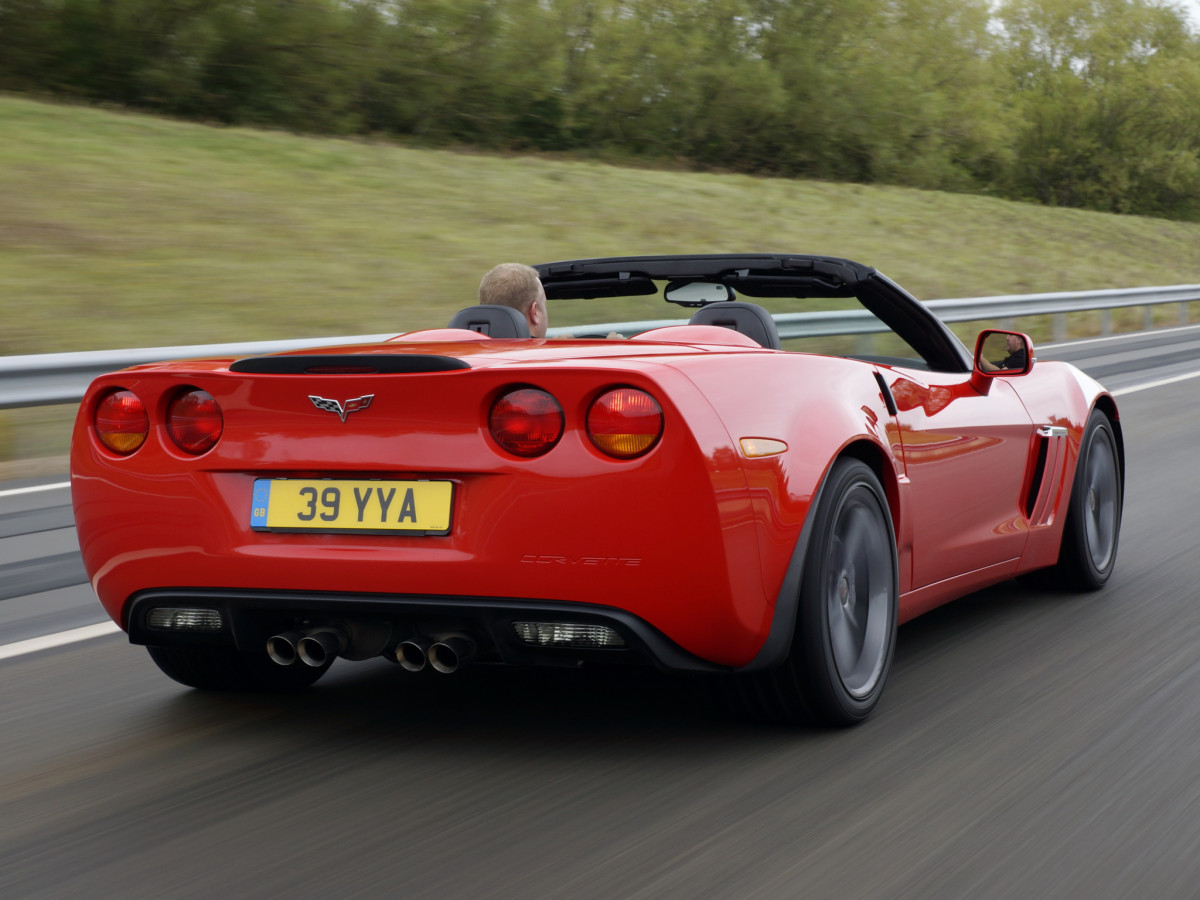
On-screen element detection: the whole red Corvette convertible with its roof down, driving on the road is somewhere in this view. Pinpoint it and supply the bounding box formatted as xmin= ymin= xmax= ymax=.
xmin=71 ymin=254 xmax=1124 ymax=725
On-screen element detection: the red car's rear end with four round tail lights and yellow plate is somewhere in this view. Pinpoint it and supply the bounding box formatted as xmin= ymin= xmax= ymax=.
xmin=72 ymin=341 xmax=782 ymax=670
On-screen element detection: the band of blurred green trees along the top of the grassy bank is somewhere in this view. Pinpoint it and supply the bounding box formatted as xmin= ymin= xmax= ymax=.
xmin=0 ymin=0 xmax=1200 ymax=220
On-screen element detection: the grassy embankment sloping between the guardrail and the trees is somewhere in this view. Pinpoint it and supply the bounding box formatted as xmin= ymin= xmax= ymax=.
xmin=0 ymin=96 xmax=1200 ymax=461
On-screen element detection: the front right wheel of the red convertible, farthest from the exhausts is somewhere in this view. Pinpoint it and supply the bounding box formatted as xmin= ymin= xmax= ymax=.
xmin=1050 ymin=409 xmax=1124 ymax=590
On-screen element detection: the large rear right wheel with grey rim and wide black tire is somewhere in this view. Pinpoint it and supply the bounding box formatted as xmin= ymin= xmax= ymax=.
xmin=727 ymin=458 xmax=899 ymax=726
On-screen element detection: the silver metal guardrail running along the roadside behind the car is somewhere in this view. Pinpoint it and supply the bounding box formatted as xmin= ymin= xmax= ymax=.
xmin=0 ymin=284 xmax=1200 ymax=409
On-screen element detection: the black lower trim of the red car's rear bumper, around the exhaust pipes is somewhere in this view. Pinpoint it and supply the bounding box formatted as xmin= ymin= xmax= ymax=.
xmin=126 ymin=588 xmax=731 ymax=672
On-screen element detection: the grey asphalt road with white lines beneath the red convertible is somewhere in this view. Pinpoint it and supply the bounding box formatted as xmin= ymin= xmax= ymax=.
xmin=0 ymin=329 xmax=1200 ymax=900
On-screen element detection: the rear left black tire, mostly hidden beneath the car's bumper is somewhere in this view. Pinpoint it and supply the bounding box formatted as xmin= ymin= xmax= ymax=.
xmin=146 ymin=647 xmax=332 ymax=692
